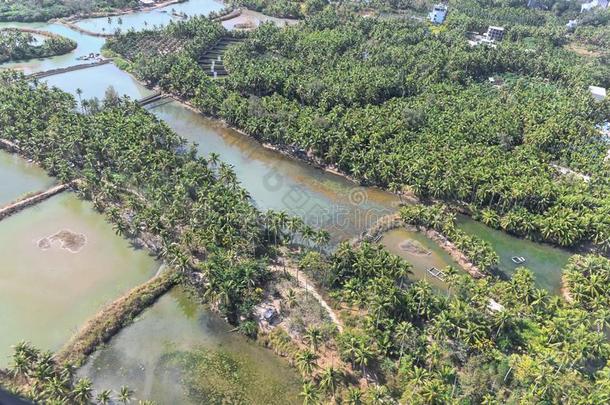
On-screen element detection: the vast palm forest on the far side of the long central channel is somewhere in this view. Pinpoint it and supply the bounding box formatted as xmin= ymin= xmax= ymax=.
xmin=104 ymin=8 xmax=610 ymax=251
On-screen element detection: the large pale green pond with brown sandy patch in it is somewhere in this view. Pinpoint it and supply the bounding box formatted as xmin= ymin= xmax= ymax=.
xmin=0 ymin=193 xmax=159 ymax=367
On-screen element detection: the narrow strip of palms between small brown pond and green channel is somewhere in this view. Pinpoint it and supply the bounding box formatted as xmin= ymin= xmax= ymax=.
xmin=400 ymin=204 xmax=499 ymax=271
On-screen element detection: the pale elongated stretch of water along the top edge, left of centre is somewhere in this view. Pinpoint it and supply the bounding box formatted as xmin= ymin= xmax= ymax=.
xmin=76 ymin=0 xmax=224 ymax=34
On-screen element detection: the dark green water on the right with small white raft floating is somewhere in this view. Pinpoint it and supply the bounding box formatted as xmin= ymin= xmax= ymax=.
xmin=458 ymin=215 xmax=572 ymax=294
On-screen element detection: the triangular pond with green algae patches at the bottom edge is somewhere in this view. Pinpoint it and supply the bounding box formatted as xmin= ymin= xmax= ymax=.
xmin=79 ymin=287 xmax=300 ymax=405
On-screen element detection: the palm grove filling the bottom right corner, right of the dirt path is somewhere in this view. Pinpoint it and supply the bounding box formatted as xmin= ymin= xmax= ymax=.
xmin=300 ymin=244 xmax=610 ymax=404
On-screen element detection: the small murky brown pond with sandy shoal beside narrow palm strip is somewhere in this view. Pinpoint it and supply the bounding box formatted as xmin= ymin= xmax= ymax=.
xmin=379 ymin=228 xmax=461 ymax=290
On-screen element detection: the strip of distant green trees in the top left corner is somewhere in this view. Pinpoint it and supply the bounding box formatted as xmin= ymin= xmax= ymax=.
xmin=0 ymin=0 xmax=140 ymax=21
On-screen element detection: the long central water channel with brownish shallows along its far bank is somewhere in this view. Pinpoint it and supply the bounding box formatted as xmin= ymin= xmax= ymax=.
xmin=152 ymin=102 xmax=398 ymax=243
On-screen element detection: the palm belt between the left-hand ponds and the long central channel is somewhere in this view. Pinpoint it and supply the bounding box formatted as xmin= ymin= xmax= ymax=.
xmin=0 ymin=73 xmax=270 ymax=321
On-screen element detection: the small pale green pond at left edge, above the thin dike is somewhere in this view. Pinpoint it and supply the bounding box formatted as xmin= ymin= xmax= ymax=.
xmin=0 ymin=149 xmax=55 ymax=207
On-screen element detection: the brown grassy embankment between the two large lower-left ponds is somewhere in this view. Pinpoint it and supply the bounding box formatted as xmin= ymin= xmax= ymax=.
xmin=55 ymin=270 xmax=180 ymax=365
